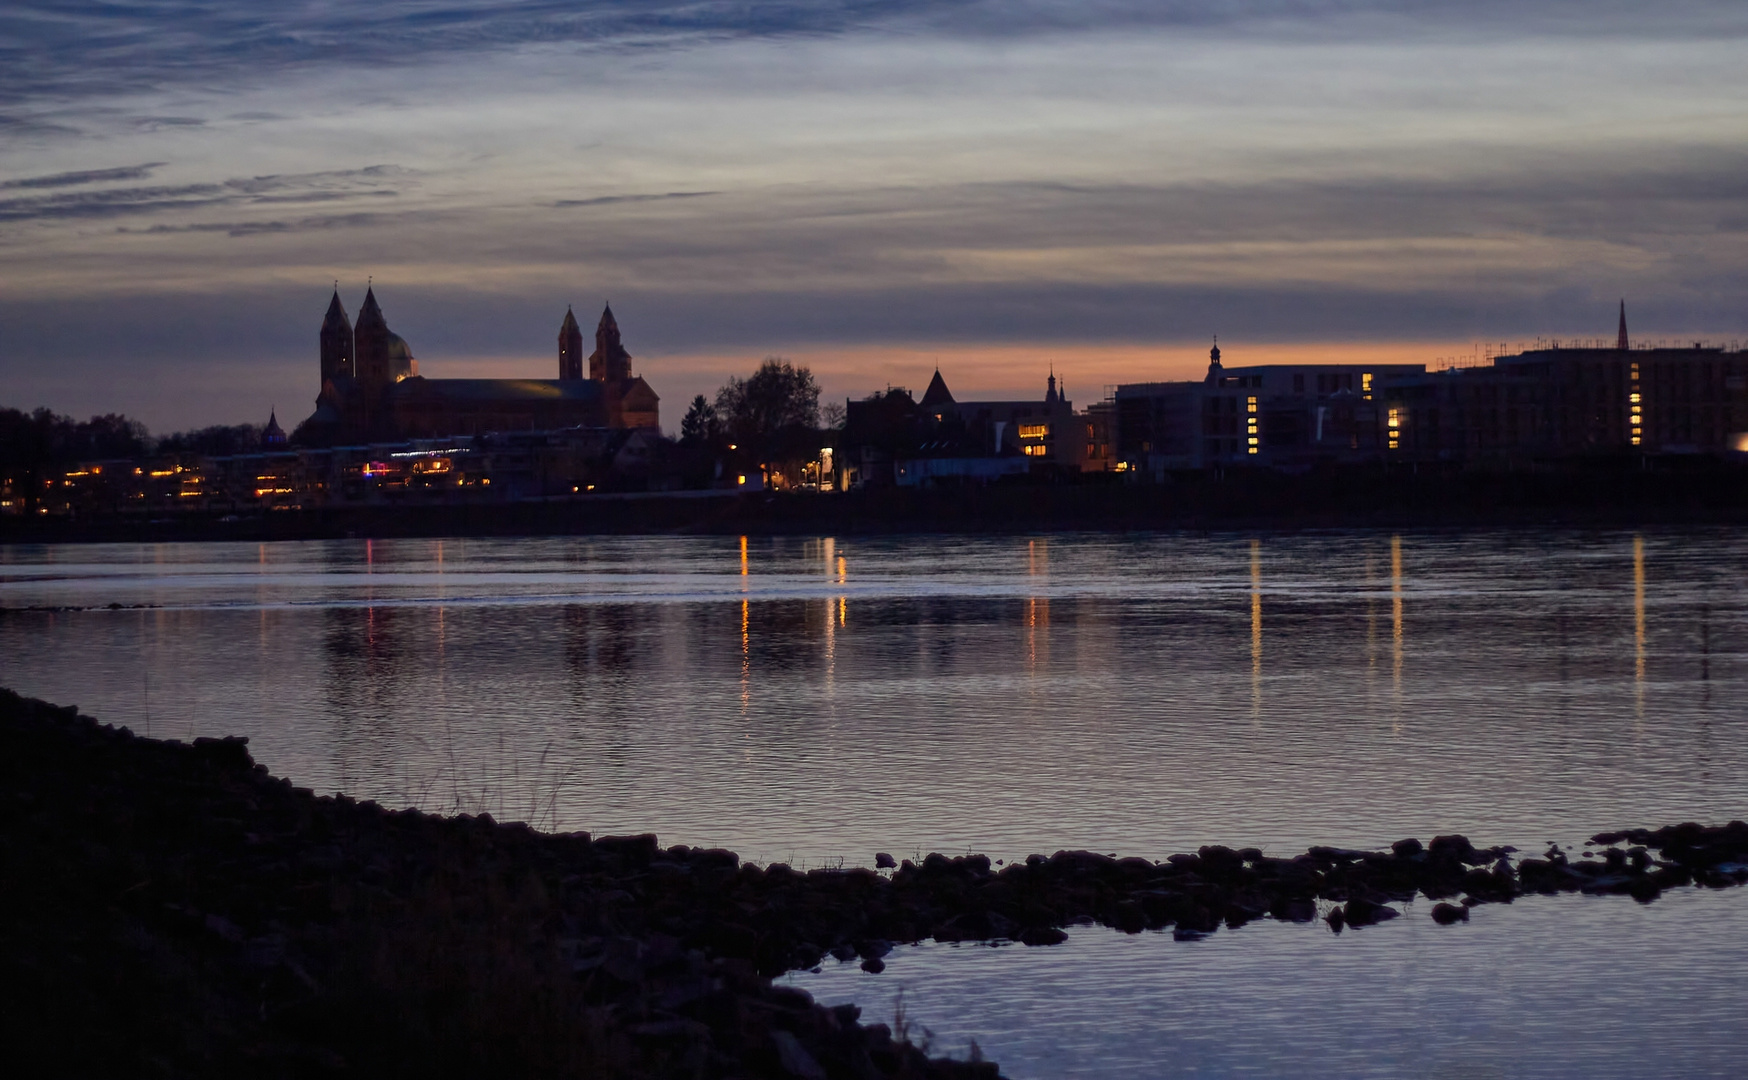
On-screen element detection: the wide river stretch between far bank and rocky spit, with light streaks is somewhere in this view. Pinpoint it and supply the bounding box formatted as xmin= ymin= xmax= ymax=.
xmin=0 ymin=531 xmax=1748 ymax=865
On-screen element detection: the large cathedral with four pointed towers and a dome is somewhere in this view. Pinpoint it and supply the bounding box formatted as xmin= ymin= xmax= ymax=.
xmin=297 ymin=288 xmax=661 ymax=444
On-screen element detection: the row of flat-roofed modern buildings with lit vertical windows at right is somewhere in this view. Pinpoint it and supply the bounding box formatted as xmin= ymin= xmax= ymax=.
xmin=1112 ymin=304 xmax=1748 ymax=474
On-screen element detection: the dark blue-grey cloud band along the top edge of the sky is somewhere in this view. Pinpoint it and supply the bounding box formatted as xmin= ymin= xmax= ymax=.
xmin=0 ymin=0 xmax=1748 ymax=110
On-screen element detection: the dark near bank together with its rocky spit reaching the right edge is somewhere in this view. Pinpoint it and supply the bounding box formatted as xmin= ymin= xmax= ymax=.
xmin=0 ymin=690 xmax=1748 ymax=1080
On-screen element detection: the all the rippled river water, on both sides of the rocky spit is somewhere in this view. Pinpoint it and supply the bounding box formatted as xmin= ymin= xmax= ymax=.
xmin=0 ymin=530 xmax=1748 ymax=1077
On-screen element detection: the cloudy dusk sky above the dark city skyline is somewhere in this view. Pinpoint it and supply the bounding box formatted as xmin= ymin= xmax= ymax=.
xmin=0 ymin=0 xmax=1748 ymax=432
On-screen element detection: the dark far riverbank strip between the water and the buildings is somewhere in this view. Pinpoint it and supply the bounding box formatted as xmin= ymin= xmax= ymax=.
xmin=0 ymin=458 xmax=1748 ymax=543
